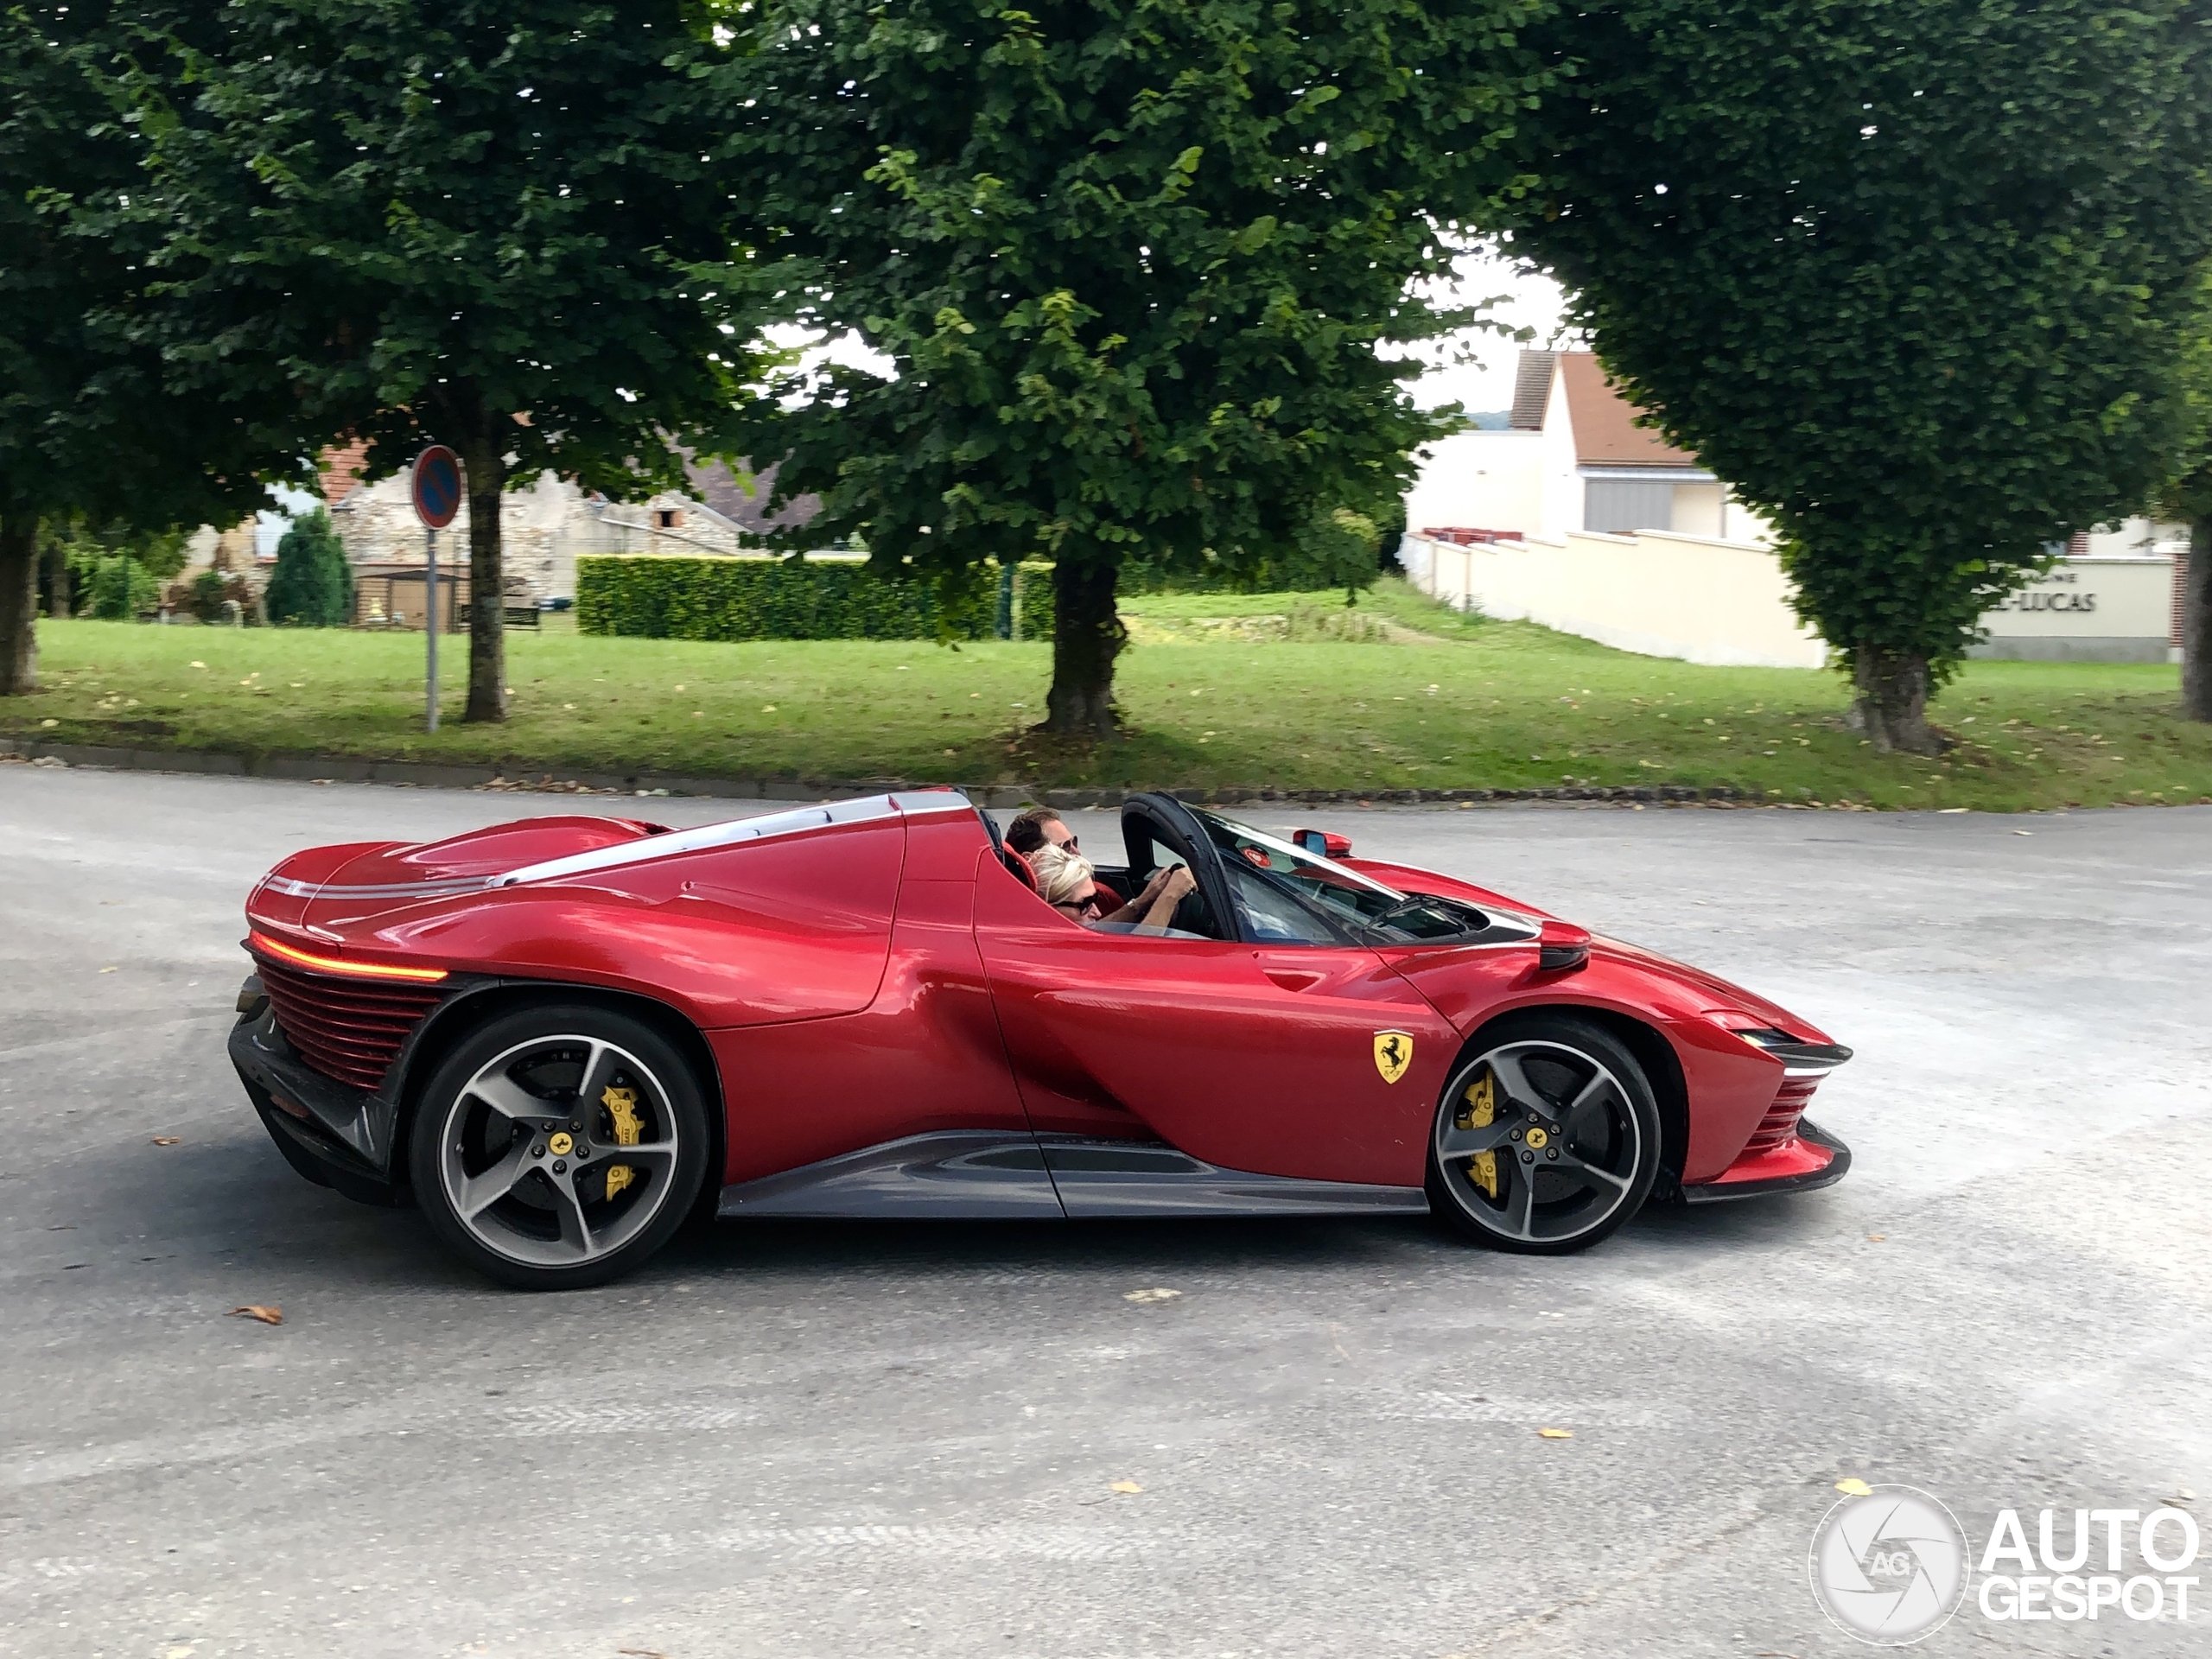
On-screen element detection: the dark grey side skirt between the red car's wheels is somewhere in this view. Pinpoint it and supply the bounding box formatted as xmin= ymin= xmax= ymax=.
xmin=719 ymin=1130 xmax=1429 ymax=1221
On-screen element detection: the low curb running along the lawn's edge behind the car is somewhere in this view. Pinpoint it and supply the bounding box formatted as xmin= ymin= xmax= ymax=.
xmin=0 ymin=736 xmax=1763 ymax=807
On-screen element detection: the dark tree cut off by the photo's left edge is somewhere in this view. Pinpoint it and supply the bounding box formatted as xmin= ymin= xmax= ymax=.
xmin=0 ymin=4 xmax=294 ymax=695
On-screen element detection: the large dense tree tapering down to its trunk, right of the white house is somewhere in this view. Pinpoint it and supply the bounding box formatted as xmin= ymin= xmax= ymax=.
xmin=1516 ymin=0 xmax=2212 ymax=752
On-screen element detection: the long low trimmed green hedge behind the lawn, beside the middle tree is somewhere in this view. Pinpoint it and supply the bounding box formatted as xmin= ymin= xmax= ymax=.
xmin=575 ymin=556 xmax=1053 ymax=641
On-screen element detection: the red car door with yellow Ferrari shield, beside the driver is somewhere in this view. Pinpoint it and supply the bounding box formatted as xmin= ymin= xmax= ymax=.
xmin=976 ymin=797 xmax=1455 ymax=1188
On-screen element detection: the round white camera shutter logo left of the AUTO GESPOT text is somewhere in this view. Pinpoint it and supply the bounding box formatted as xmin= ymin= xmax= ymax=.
xmin=1808 ymin=1486 xmax=1968 ymax=1648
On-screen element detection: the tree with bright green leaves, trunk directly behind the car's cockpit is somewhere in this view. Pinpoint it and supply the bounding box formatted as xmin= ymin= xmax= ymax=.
xmin=716 ymin=0 xmax=1537 ymax=734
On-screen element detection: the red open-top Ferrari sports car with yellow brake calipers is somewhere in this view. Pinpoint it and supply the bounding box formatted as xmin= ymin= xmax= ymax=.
xmin=230 ymin=790 xmax=1849 ymax=1287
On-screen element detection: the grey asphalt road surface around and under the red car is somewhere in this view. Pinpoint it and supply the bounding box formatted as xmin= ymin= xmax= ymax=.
xmin=0 ymin=766 xmax=2212 ymax=1659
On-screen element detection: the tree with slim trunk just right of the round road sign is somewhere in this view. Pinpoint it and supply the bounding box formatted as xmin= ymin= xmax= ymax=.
xmin=133 ymin=0 xmax=760 ymax=721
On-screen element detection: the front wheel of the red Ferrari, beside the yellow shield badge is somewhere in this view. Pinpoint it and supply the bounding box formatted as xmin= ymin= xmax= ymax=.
xmin=1429 ymin=1015 xmax=1659 ymax=1256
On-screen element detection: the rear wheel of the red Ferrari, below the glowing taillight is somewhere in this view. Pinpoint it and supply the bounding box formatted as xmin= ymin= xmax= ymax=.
xmin=410 ymin=1004 xmax=712 ymax=1289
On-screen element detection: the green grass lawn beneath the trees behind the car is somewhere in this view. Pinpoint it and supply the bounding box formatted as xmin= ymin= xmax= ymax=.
xmin=0 ymin=584 xmax=2212 ymax=810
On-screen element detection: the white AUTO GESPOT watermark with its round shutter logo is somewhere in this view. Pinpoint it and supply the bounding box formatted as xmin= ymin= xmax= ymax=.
xmin=1808 ymin=1480 xmax=2199 ymax=1648
